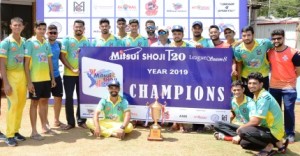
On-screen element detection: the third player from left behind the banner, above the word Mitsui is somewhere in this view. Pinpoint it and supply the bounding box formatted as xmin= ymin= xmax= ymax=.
xmin=122 ymin=19 xmax=149 ymax=47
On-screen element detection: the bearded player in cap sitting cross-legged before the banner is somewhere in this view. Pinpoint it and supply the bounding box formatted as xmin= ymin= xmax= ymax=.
xmin=87 ymin=80 xmax=133 ymax=139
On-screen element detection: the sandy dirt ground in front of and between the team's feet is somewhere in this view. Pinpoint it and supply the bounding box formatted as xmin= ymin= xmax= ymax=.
xmin=0 ymin=98 xmax=300 ymax=156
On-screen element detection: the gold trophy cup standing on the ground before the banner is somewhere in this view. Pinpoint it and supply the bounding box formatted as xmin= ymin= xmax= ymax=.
xmin=146 ymin=98 xmax=164 ymax=141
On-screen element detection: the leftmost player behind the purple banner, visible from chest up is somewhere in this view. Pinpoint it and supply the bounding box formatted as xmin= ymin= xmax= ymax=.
xmin=92 ymin=18 xmax=121 ymax=47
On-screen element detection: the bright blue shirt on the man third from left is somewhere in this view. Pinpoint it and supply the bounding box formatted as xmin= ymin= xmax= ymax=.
xmin=50 ymin=41 xmax=60 ymax=77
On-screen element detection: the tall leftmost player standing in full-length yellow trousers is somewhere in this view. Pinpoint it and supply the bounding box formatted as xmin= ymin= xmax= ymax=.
xmin=0 ymin=17 xmax=26 ymax=146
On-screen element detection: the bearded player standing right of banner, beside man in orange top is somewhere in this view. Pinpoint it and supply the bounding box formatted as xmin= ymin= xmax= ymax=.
xmin=234 ymin=26 xmax=273 ymax=97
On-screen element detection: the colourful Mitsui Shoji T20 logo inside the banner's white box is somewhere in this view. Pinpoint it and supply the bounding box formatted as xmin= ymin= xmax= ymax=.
xmin=85 ymin=69 xmax=117 ymax=88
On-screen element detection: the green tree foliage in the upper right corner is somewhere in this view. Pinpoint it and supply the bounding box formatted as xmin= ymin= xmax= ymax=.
xmin=258 ymin=0 xmax=300 ymax=18
